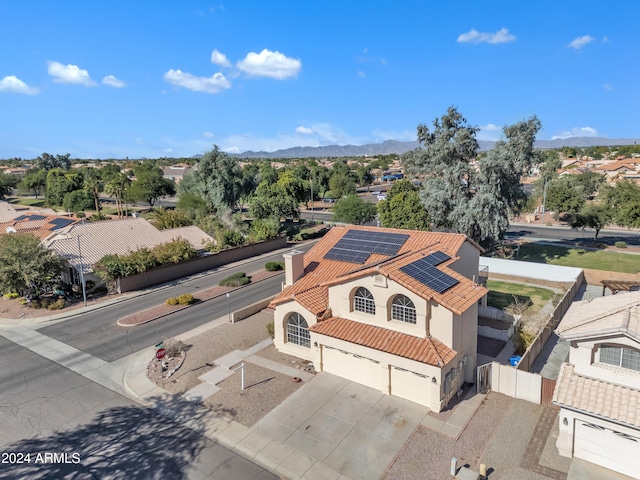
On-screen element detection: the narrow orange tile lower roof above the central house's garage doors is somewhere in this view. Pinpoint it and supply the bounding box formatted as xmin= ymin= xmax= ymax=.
xmin=309 ymin=317 xmax=457 ymax=367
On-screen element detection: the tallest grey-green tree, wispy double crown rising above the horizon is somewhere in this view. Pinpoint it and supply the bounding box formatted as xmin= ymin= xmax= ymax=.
xmin=404 ymin=107 xmax=540 ymax=245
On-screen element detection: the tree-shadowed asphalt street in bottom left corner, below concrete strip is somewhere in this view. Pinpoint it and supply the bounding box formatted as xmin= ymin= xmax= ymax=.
xmin=0 ymin=337 xmax=278 ymax=480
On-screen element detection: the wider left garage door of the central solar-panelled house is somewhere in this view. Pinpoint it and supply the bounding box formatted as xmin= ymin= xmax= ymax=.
xmin=322 ymin=346 xmax=384 ymax=390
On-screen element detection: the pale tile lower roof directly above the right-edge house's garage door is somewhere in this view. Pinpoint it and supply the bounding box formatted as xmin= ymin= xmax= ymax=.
xmin=553 ymin=363 xmax=640 ymax=428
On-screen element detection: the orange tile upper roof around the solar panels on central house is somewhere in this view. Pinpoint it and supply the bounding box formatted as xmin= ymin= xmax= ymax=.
xmin=271 ymin=226 xmax=486 ymax=316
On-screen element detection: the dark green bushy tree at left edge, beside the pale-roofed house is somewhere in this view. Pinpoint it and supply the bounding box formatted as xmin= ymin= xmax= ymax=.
xmin=0 ymin=233 xmax=62 ymax=294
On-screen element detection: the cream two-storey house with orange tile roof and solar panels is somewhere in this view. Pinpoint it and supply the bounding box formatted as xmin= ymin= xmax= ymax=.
xmin=271 ymin=226 xmax=487 ymax=412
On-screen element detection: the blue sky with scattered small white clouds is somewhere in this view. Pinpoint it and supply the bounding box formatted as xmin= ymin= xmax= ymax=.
xmin=0 ymin=0 xmax=640 ymax=158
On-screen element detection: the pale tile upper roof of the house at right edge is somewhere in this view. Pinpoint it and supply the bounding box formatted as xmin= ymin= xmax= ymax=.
xmin=556 ymin=292 xmax=640 ymax=341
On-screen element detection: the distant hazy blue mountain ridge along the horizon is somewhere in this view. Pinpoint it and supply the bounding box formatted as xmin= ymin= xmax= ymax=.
xmin=235 ymin=137 xmax=640 ymax=158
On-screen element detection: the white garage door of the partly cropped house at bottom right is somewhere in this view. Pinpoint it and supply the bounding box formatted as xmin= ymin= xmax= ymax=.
xmin=573 ymin=420 xmax=640 ymax=478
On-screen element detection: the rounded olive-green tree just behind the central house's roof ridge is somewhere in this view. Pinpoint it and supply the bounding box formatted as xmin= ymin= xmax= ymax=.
xmin=378 ymin=180 xmax=431 ymax=230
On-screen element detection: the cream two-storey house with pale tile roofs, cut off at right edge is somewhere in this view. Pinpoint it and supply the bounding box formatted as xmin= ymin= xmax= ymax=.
xmin=553 ymin=292 xmax=640 ymax=478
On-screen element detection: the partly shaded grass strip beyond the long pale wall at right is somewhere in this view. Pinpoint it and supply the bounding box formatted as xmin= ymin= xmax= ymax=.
xmin=516 ymin=243 xmax=640 ymax=273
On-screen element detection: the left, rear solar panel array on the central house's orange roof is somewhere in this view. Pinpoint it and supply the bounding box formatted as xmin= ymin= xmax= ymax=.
xmin=324 ymin=230 xmax=409 ymax=264
